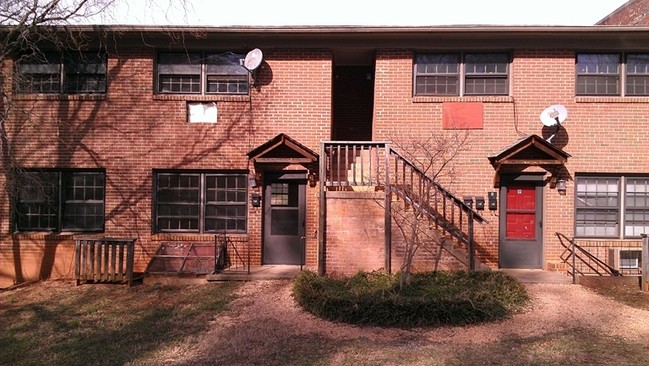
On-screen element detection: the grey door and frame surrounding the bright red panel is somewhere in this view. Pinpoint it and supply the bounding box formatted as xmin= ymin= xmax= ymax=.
xmin=498 ymin=173 xmax=545 ymax=269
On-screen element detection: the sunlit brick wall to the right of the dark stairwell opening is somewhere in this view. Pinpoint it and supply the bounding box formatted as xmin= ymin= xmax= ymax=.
xmin=374 ymin=49 xmax=649 ymax=268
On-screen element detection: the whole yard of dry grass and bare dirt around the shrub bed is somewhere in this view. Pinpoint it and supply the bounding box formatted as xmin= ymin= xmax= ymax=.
xmin=0 ymin=281 xmax=649 ymax=366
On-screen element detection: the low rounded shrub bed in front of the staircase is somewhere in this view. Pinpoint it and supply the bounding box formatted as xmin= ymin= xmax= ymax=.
xmin=293 ymin=271 xmax=529 ymax=327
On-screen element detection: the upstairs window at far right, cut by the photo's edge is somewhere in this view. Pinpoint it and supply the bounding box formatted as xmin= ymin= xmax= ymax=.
xmin=576 ymin=53 xmax=649 ymax=96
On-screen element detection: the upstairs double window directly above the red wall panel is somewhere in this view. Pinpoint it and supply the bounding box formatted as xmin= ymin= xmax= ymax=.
xmin=414 ymin=53 xmax=509 ymax=96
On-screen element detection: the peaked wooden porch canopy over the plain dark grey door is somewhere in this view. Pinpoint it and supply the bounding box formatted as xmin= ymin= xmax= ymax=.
xmin=247 ymin=133 xmax=318 ymax=169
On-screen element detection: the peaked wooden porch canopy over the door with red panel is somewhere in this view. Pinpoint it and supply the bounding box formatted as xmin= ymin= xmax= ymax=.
xmin=489 ymin=135 xmax=570 ymax=187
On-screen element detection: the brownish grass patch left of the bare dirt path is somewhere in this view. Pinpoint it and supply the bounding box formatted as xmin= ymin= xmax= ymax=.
xmin=0 ymin=281 xmax=238 ymax=366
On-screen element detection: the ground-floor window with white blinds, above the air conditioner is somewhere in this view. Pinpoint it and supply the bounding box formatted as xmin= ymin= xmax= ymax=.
xmin=575 ymin=176 xmax=649 ymax=238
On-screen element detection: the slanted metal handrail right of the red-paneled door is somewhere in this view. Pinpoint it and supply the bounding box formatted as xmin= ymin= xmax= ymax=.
xmin=555 ymin=232 xmax=622 ymax=283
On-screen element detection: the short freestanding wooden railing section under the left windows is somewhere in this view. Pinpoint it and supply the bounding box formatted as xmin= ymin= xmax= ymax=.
xmin=74 ymin=238 xmax=136 ymax=286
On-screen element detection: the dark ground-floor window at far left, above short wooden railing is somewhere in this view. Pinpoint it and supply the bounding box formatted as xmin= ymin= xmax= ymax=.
xmin=16 ymin=171 xmax=106 ymax=231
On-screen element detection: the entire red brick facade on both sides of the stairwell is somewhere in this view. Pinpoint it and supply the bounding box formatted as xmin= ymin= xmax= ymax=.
xmin=0 ymin=33 xmax=649 ymax=286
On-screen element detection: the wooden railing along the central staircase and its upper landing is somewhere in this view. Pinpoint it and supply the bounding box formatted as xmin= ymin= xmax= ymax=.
xmin=320 ymin=141 xmax=485 ymax=270
